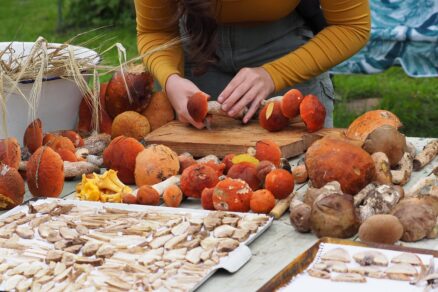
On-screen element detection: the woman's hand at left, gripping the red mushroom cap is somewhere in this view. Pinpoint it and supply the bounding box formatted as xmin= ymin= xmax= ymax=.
xmin=166 ymin=74 xmax=204 ymax=129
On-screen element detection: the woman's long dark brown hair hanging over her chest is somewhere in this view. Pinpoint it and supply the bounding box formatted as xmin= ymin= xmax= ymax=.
xmin=175 ymin=0 xmax=217 ymax=75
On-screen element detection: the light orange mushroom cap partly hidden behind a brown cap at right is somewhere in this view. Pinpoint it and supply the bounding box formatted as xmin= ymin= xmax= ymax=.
xmin=345 ymin=110 xmax=402 ymax=141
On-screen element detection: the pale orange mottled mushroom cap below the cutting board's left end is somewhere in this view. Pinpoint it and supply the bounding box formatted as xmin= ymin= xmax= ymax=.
xmin=134 ymin=144 xmax=179 ymax=187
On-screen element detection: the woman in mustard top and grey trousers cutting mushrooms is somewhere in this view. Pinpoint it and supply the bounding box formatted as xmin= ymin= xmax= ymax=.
xmin=135 ymin=0 xmax=370 ymax=128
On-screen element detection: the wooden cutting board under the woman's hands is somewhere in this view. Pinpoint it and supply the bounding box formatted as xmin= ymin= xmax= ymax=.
xmin=145 ymin=117 xmax=344 ymax=158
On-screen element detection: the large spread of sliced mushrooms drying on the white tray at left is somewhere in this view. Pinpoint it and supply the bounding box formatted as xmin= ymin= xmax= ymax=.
xmin=0 ymin=202 xmax=268 ymax=291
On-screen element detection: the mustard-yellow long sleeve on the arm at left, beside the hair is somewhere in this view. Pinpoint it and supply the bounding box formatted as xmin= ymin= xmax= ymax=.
xmin=135 ymin=0 xmax=184 ymax=88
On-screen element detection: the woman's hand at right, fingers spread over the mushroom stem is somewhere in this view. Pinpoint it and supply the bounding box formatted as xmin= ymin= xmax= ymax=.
xmin=218 ymin=67 xmax=275 ymax=123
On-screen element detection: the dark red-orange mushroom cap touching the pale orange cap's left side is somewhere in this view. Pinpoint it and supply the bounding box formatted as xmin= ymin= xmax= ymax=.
xmin=103 ymin=136 xmax=144 ymax=184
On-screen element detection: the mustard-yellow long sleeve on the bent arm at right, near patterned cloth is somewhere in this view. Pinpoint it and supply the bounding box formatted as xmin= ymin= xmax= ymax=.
xmin=263 ymin=0 xmax=371 ymax=90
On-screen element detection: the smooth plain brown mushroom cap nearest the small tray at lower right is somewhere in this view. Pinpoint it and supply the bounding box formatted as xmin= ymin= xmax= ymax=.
xmin=359 ymin=214 xmax=403 ymax=244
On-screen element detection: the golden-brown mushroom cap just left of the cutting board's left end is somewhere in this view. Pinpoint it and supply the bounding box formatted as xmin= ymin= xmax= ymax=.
xmin=111 ymin=111 xmax=151 ymax=141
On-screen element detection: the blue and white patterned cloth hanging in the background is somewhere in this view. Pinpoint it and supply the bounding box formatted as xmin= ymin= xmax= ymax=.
xmin=331 ymin=0 xmax=438 ymax=77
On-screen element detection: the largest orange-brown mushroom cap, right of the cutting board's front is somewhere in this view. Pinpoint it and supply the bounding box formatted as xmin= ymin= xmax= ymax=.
xmin=305 ymin=136 xmax=375 ymax=195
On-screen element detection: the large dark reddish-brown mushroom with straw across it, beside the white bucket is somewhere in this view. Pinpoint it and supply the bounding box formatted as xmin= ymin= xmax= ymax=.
xmin=105 ymin=65 xmax=154 ymax=119
